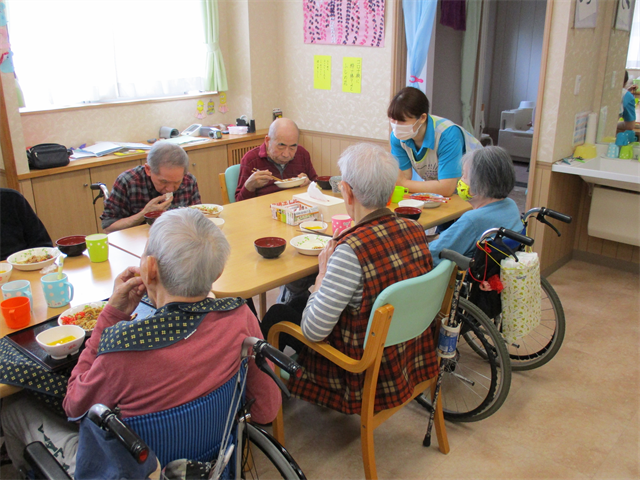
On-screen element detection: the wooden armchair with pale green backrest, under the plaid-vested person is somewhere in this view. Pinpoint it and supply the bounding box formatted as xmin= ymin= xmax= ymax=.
xmin=268 ymin=260 xmax=455 ymax=480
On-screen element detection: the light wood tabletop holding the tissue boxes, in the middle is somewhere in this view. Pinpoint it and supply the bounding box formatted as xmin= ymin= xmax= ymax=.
xmin=109 ymin=188 xmax=471 ymax=298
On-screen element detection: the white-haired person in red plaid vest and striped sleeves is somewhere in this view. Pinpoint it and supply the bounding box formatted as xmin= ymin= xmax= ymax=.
xmin=262 ymin=144 xmax=437 ymax=414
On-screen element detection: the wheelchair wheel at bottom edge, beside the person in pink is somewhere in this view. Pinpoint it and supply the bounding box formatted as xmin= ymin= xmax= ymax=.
xmin=241 ymin=423 xmax=307 ymax=480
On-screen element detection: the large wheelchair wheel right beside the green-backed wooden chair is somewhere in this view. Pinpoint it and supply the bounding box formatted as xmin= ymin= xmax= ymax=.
xmin=418 ymin=297 xmax=511 ymax=422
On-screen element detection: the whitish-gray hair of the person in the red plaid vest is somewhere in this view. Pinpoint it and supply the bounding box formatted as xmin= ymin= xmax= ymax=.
xmin=338 ymin=143 xmax=399 ymax=209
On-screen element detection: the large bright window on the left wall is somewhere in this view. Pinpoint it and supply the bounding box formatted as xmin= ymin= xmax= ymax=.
xmin=5 ymin=0 xmax=207 ymax=109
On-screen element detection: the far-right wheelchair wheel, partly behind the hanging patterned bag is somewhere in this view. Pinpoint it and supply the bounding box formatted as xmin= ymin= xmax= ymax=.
xmin=500 ymin=277 xmax=566 ymax=371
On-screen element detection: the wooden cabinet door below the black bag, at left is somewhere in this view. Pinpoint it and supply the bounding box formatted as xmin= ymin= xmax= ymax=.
xmin=31 ymin=170 xmax=98 ymax=242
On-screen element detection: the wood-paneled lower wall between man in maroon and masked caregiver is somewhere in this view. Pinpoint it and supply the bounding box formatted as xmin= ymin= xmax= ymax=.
xmin=299 ymin=130 xmax=390 ymax=176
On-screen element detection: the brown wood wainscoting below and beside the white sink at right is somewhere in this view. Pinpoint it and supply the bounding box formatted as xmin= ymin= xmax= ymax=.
xmin=529 ymin=162 xmax=640 ymax=275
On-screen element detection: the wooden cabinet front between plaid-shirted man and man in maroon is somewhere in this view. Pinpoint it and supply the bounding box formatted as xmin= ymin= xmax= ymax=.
xmin=188 ymin=146 xmax=227 ymax=205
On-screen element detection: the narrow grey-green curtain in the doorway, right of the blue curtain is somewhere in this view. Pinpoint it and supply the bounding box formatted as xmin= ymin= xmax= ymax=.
xmin=460 ymin=0 xmax=482 ymax=135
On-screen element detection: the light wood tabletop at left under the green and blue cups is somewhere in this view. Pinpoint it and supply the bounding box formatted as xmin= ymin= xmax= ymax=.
xmin=0 ymin=248 xmax=140 ymax=338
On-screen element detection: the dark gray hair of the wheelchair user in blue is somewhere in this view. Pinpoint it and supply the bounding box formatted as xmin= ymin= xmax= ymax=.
xmin=462 ymin=147 xmax=516 ymax=199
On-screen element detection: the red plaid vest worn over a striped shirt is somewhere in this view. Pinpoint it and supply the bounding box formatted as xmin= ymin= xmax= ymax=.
xmin=289 ymin=215 xmax=438 ymax=414
